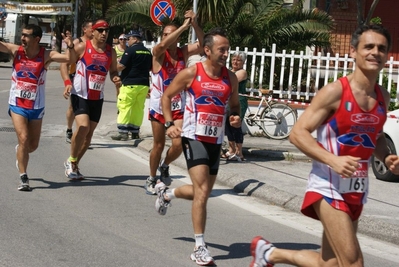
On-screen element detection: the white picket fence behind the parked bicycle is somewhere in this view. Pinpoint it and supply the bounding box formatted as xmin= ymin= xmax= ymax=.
xmin=146 ymin=42 xmax=399 ymax=105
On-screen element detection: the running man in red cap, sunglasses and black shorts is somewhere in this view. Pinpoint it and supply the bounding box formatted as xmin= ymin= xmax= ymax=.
xmin=64 ymin=20 xmax=120 ymax=180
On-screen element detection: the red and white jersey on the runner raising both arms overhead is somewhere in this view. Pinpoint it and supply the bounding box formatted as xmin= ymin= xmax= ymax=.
xmin=150 ymin=47 xmax=186 ymax=122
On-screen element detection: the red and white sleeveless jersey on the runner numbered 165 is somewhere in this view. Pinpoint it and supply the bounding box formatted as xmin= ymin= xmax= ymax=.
xmin=307 ymin=77 xmax=387 ymax=205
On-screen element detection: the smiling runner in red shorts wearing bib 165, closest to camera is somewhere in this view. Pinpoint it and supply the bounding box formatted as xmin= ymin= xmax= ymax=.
xmin=250 ymin=25 xmax=399 ymax=267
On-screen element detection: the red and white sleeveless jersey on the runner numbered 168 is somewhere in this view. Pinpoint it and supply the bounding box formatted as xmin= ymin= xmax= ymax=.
xmin=182 ymin=62 xmax=232 ymax=144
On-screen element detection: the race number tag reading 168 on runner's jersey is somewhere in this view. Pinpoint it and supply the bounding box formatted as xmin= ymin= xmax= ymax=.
xmin=195 ymin=112 xmax=224 ymax=137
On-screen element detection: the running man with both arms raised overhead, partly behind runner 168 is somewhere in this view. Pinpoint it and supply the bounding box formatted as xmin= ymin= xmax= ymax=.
xmin=145 ymin=10 xmax=204 ymax=195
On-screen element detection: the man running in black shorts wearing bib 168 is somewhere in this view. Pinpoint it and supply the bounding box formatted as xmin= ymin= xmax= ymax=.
xmin=155 ymin=28 xmax=241 ymax=265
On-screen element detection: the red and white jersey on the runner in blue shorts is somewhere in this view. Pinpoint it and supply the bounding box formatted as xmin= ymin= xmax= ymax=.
xmin=8 ymin=46 xmax=47 ymax=109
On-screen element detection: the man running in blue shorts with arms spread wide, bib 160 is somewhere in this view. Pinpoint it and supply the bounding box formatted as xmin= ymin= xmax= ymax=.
xmin=0 ymin=24 xmax=76 ymax=191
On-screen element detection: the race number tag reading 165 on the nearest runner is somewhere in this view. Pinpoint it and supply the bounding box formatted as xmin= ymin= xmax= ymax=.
xmin=339 ymin=160 xmax=369 ymax=194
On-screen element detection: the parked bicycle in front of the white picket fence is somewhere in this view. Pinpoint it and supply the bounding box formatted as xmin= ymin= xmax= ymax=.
xmin=240 ymin=89 xmax=298 ymax=140
